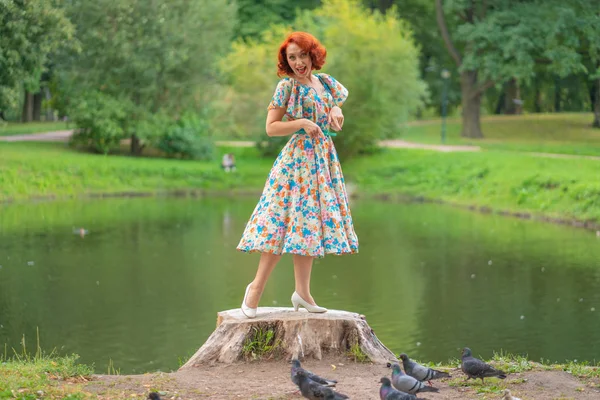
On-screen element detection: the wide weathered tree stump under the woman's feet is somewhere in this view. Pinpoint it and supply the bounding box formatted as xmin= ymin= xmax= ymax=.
xmin=181 ymin=307 xmax=398 ymax=369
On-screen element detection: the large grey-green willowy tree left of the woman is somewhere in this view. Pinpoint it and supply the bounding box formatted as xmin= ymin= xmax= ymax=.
xmin=59 ymin=0 xmax=236 ymax=154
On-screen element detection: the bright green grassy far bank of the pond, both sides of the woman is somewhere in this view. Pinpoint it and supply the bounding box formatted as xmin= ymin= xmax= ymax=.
xmin=0 ymin=143 xmax=600 ymax=225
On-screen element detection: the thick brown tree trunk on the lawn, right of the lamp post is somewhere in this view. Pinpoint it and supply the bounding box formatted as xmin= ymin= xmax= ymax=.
xmin=460 ymin=71 xmax=483 ymax=139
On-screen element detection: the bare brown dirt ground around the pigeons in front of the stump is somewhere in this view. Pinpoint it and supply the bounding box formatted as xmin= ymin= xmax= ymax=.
xmin=85 ymin=360 xmax=600 ymax=400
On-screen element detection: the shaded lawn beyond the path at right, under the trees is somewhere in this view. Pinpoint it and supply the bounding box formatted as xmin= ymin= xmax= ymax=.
xmin=397 ymin=113 xmax=600 ymax=156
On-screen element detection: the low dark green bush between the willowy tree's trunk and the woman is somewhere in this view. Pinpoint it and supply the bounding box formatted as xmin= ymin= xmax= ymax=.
xmin=157 ymin=115 xmax=215 ymax=160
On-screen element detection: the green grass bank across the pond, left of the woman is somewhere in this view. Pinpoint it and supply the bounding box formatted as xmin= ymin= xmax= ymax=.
xmin=0 ymin=142 xmax=273 ymax=201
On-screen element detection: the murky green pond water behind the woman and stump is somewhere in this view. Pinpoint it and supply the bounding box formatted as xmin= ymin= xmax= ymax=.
xmin=0 ymin=197 xmax=600 ymax=373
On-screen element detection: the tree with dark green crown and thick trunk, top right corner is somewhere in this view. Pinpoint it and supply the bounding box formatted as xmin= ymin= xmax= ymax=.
xmin=435 ymin=0 xmax=597 ymax=138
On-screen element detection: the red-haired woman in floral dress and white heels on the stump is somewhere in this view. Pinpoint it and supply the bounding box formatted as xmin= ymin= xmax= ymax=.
xmin=237 ymin=32 xmax=358 ymax=318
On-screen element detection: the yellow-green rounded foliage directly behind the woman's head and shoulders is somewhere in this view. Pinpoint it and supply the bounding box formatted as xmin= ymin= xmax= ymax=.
xmin=221 ymin=0 xmax=427 ymax=155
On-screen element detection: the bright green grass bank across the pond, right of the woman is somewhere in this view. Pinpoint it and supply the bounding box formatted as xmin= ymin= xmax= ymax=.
xmin=343 ymin=149 xmax=600 ymax=221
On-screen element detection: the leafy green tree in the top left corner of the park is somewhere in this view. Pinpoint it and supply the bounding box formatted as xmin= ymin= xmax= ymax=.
xmin=0 ymin=0 xmax=73 ymax=121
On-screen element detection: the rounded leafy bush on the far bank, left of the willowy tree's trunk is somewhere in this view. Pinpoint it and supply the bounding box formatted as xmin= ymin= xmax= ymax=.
xmin=71 ymin=92 xmax=131 ymax=154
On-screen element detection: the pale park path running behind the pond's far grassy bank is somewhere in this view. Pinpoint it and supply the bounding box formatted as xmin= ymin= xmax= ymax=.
xmin=0 ymin=130 xmax=600 ymax=161
